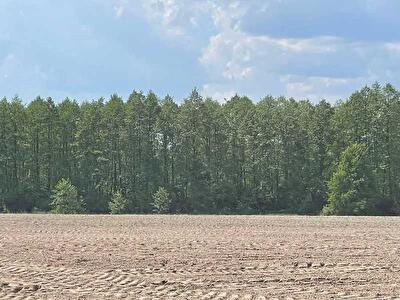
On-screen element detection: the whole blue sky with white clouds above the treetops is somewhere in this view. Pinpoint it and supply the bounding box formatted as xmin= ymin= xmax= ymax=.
xmin=0 ymin=0 xmax=400 ymax=102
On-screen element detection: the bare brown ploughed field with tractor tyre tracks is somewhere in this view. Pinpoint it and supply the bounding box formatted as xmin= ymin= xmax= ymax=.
xmin=0 ymin=215 xmax=400 ymax=299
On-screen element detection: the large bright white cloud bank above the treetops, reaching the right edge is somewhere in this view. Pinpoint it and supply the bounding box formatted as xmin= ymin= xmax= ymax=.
xmin=195 ymin=1 xmax=400 ymax=101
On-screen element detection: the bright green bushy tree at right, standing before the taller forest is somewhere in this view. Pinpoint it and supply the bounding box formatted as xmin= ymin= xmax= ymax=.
xmin=323 ymin=143 xmax=378 ymax=215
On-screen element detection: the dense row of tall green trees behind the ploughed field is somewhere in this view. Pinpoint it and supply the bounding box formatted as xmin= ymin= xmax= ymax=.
xmin=0 ymin=84 xmax=400 ymax=214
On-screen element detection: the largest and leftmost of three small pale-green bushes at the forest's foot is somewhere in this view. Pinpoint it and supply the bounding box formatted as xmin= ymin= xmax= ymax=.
xmin=51 ymin=179 xmax=85 ymax=214
